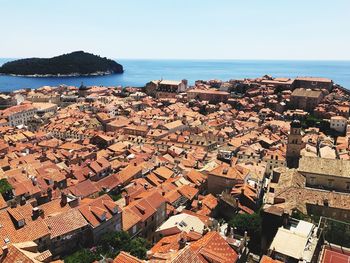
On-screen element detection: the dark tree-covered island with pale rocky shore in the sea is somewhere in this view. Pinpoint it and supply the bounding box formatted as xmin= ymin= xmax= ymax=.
xmin=0 ymin=51 xmax=124 ymax=77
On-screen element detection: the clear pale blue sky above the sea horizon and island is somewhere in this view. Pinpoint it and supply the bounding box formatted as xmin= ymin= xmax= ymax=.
xmin=0 ymin=0 xmax=350 ymax=60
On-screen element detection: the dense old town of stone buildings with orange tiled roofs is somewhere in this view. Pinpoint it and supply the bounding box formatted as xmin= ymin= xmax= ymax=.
xmin=0 ymin=76 xmax=350 ymax=263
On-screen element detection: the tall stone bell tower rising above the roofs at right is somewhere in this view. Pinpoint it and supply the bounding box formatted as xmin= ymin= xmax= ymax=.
xmin=286 ymin=120 xmax=303 ymax=168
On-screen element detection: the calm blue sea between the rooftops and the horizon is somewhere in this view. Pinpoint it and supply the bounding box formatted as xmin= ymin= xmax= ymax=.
xmin=0 ymin=58 xmax=350 ymax=91
